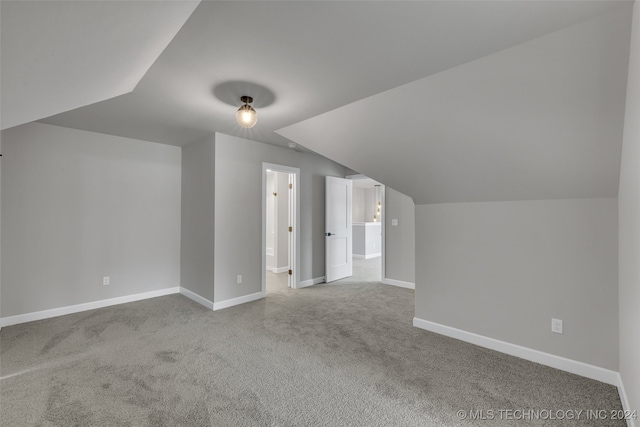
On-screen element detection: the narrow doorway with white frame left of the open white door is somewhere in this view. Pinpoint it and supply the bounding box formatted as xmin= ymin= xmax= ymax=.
xmin=262 ymin=163 xmax=300 ymax=294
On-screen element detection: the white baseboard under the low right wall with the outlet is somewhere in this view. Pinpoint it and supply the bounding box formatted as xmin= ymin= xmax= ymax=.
xmin=413 ymin=317 xmax=620 ymax=386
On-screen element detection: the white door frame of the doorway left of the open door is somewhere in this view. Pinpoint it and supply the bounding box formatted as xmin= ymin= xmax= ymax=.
xmin=261 ymin=162 xmax=300 ymax=294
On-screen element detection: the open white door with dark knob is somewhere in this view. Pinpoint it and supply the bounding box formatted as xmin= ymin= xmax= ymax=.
xmin=325 ymin=176 xmax=353 ymax=283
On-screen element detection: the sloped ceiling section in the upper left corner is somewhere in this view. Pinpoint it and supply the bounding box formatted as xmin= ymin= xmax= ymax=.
xmin=0 ymin=0 xmax=199 ymax=129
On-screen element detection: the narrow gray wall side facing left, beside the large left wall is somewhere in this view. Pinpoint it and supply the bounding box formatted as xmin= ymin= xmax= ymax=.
xmin=180 ymin=135 xmax=215 ymax=301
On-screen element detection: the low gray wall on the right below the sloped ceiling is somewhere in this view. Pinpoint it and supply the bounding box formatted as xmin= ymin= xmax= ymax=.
xmin=415 ymin=199 xmax=618 ymax=370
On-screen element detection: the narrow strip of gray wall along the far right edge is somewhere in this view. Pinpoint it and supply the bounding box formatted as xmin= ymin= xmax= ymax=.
xmin=618 ymin=2 xmax=640 ymax=410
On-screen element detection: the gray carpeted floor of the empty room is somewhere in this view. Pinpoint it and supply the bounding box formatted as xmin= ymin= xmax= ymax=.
xmin=0 ymin=264 xmax=625 ymax=426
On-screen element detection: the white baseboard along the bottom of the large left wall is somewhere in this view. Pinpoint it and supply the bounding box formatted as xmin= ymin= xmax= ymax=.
xmin=0 ymin=286 xmax=180 ymax=327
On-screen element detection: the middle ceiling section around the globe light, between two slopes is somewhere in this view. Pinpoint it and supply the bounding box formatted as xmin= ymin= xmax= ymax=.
xmin=37 ymin=1 xmax=619 ymax=146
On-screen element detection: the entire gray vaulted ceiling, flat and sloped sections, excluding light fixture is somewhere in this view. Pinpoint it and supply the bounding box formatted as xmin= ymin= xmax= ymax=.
xmin=0 ymin=0 xmax=632 ymax=203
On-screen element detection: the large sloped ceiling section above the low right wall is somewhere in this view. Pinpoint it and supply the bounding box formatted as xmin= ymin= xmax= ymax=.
xmin=278 ymin=9 xmax=630 ymax=204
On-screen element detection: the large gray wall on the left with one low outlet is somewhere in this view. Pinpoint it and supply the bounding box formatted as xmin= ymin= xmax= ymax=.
xmin=1 ymin=123 xmax=181 ymax=317
